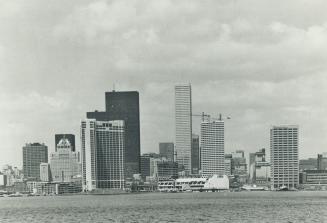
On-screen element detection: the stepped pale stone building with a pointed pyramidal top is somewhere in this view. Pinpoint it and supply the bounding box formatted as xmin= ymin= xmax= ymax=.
xmin=50 ymin=136 xmax=81 ymax=182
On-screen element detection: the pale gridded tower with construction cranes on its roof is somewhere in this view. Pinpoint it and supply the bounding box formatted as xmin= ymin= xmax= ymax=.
xmin=201 ymin=120 xmax=225 ymax=177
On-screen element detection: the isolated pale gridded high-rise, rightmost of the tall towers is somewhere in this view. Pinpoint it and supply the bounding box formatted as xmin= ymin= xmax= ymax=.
xmin=270 ymin=125 xmax=299 ymax=189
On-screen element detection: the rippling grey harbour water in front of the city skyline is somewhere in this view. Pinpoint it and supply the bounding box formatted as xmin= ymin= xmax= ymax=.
xmin=0 ymin=192 xmax=327 ymax=223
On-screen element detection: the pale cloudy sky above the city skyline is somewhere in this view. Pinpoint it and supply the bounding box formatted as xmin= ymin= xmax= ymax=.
xmin=0 ymin=0 xmax=327 ymax=167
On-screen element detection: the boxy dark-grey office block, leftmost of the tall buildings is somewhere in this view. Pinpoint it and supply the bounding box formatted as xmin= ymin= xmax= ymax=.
xmin=23 ymin=143 xmax=48 ymax=180
